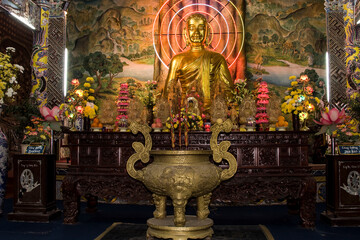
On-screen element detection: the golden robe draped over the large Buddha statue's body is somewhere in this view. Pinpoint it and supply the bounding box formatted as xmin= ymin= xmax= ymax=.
xmin=164 ymin=50 xmax=234 ymax=111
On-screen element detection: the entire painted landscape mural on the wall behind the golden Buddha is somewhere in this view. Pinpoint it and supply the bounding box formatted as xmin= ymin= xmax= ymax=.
xmin=67 ymin=0 xmax=326 ymax=124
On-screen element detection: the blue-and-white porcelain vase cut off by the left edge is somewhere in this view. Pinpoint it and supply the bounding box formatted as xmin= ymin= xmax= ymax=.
xmin=0 ymin=128 xmax=8 ymax=215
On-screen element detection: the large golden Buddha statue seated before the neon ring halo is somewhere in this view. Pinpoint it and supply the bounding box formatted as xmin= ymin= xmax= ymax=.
xmin=163 ymin=13 xmax=234 ymax=112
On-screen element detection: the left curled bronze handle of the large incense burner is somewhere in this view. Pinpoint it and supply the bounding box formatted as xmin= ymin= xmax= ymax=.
xmin=126 ymin=122 xmax=152 ymax=182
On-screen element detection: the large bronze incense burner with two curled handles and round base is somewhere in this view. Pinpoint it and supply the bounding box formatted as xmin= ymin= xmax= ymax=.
xmin=126 ymin=121 xmax=237 ymax=240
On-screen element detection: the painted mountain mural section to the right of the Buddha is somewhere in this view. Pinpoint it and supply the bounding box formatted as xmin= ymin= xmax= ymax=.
xmin=245 ymin=0 xmax=326 ymax=86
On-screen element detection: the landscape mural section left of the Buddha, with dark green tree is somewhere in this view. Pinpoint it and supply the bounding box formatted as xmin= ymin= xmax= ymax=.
xmin=67 ymin=0 xmax=159 ymax=124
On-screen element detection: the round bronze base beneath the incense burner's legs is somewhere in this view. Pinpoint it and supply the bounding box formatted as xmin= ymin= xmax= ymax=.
xmin=146 ymin=215 xmax=214 ymax=240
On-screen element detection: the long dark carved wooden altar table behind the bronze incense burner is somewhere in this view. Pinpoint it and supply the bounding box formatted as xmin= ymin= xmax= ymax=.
xmin=62 ymin=131 xmax=316 ymax=228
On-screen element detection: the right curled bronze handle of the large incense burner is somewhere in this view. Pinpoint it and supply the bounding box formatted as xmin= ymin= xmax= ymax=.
xmin=210 ymin=119 xmax=237 ymax=181
